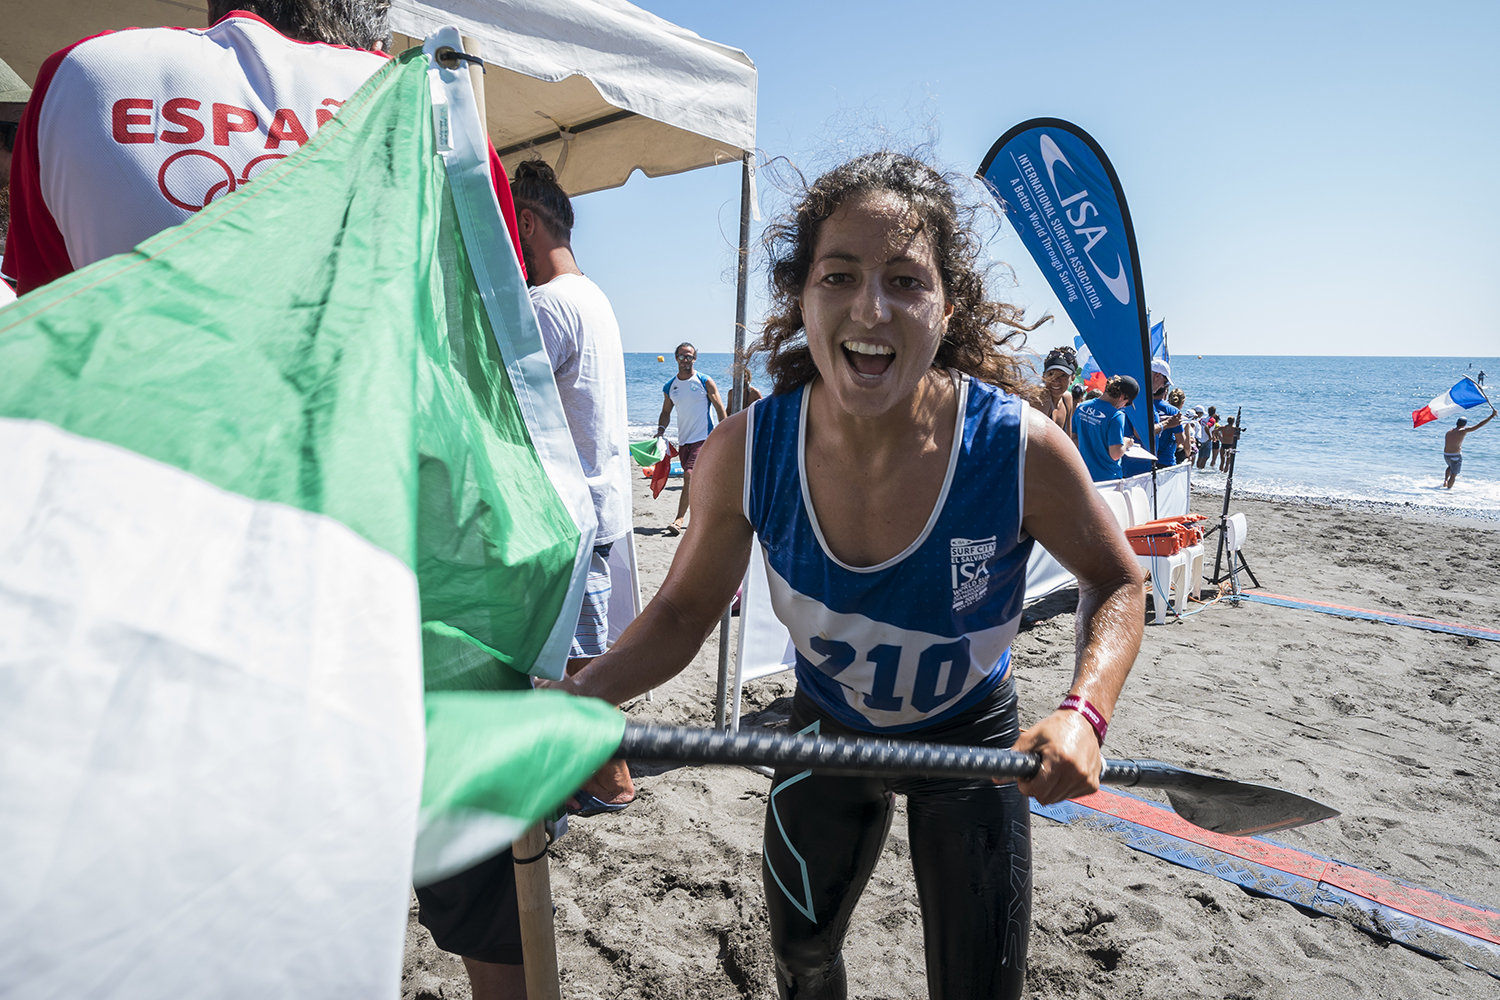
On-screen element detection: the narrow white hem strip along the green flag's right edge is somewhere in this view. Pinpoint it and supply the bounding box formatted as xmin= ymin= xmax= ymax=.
xmin=422 ymin=27 xmax=599 ymax=681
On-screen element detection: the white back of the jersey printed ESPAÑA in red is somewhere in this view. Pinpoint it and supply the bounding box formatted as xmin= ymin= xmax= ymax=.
xmin=21 ymin=13 xmax=387 ymax=281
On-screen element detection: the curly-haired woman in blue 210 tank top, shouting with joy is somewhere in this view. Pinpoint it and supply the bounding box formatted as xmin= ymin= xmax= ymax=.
xmin=557 ymin=153 xmax=1145 ymax=999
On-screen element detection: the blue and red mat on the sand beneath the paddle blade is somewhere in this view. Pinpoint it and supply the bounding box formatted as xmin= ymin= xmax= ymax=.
xmin=1032 ymin=789 xmax=1500 ymax=979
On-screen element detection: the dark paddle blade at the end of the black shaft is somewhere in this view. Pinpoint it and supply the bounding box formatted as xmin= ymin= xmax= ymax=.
xmin=1106 ymin=760 xmax=1340 ymax=837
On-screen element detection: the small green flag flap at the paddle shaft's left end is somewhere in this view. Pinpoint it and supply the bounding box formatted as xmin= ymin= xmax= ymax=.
xmin=422 ymin=691 xmax=626 ymax=825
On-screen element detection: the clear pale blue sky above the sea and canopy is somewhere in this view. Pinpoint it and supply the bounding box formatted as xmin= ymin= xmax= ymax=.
xmin=575 ymin=0 xmax=1500 ymax=358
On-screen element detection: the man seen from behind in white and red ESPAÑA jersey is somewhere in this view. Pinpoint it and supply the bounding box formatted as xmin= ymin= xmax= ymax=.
xmin=5 ymin=0 xmax=528 ymax=295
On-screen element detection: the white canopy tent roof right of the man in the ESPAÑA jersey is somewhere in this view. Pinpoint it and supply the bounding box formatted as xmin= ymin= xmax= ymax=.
xmin=390 ymin=0 xmax=756 ymax=195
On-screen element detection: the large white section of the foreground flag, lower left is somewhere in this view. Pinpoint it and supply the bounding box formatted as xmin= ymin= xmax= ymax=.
xmin=0 ymin=418 xmax=425 ymax=1000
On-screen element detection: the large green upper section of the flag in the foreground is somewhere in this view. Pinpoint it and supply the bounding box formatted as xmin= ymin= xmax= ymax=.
xmin=0 ymin=49 xmax=582 ymax=688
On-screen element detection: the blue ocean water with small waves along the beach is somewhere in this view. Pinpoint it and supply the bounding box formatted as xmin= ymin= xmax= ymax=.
xmin=626 ymin=354 xmax=1500 ymax=519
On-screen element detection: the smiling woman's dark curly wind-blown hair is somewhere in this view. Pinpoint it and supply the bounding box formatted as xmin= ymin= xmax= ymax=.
xmin=750 ymin=151 xmax=1046 ymax=399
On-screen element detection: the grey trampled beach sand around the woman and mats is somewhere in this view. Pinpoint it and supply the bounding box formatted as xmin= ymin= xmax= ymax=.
xmin=402 ymin=476 xmax=1500 ymax=1000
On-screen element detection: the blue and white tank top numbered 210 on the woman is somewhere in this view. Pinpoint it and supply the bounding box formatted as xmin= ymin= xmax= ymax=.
xmin=744 ymin=378 xmax=1032 ymax=733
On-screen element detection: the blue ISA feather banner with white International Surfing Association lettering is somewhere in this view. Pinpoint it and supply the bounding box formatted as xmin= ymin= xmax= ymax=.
xmin=980 ymin=118 xmax=1152 ymax=450
